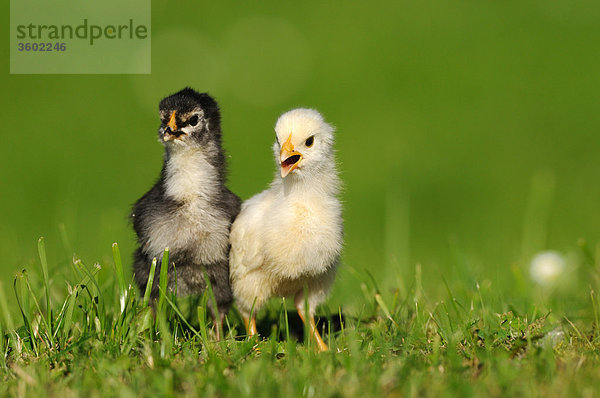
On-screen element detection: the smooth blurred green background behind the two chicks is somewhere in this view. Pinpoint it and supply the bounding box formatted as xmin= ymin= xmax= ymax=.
xmin=0 ymin=0 xmax=600 ymax=310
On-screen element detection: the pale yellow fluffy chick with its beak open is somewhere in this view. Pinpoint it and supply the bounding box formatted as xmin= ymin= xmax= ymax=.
xmin=229 ymin=109 xmax=343 ymax=351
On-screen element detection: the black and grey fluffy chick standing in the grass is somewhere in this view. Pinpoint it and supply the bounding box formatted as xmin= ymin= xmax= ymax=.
xmin=131 ymin=88 xmax=241 ymax=318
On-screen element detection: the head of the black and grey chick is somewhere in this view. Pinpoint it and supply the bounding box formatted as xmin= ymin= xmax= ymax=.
xmin=158 ymin=87 xmax=221 ymax=148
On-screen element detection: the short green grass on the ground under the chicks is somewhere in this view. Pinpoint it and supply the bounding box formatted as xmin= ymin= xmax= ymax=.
xmin=0 ymin=240 xmax=600 ymax=397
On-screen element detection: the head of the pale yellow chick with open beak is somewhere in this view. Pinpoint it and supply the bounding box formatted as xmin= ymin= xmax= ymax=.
xmin=273 ymin=108 xmax=334 ymax=178
